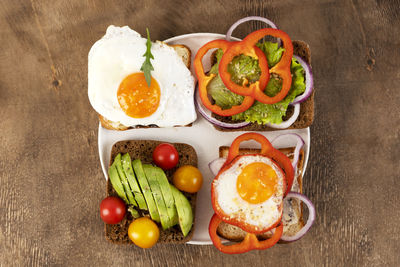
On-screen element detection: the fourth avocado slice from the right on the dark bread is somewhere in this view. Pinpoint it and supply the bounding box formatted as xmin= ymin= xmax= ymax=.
xmin=132 ymin=159 xmax=160 ymax=222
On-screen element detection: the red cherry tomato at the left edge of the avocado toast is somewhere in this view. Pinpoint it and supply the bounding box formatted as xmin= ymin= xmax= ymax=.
xmin=100 ymin=197 xmax=126 ymax=224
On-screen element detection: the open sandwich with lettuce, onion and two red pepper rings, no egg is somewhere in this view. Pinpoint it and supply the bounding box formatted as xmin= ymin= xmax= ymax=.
xmin=194 ymin=17 xmax=314 ymax=131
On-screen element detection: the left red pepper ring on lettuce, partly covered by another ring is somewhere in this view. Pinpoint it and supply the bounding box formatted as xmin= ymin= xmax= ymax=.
xmin=193 ymin=39 xmax=254 ymax=117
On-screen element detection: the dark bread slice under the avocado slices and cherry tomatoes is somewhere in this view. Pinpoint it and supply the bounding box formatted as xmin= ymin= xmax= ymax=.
xmin=105 ymin=140 xmax=197 ymax=244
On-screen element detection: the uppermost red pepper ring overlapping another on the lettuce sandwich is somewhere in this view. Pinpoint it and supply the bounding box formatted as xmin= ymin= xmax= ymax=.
xmin=219 ymin=28 xmax=293 ymax=104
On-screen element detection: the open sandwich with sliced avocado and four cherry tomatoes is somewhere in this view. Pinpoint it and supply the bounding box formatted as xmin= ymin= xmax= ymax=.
xmin=100 ymin=140 xmax=203 ymax=248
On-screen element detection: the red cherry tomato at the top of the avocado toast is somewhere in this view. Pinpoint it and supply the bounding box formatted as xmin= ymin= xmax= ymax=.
xmin=153 ymin=143 xmax=179 ymax=170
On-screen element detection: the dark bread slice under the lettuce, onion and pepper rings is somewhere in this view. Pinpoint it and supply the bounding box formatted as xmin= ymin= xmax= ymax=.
xmin=211 ymin=41 xmax=315 ymax=132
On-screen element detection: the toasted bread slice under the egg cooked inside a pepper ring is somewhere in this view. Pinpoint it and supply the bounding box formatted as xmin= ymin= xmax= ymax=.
xmin=217 ymin=146 xmax=304 ymax=242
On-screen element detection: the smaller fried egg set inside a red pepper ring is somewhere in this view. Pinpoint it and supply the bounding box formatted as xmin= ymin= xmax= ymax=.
xmin=212 ymin=155 xmax=286 ymax=231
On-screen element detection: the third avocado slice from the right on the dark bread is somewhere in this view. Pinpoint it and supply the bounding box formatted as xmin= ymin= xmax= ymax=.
xmin=143 ymin=164 xmax=172 ymax=230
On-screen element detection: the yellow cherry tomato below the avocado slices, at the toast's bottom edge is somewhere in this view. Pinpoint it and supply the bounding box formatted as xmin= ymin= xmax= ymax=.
xmin=128 ymin=217 xmax=160 ymax=248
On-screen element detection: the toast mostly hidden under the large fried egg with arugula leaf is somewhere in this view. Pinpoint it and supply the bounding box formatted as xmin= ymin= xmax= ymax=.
xmin=97 ymin=44 xmax=192 ymax=131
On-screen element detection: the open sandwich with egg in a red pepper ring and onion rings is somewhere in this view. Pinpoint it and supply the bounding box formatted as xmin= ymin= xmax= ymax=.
xmin=209 ymin=133 xmax=315 ymax=254
